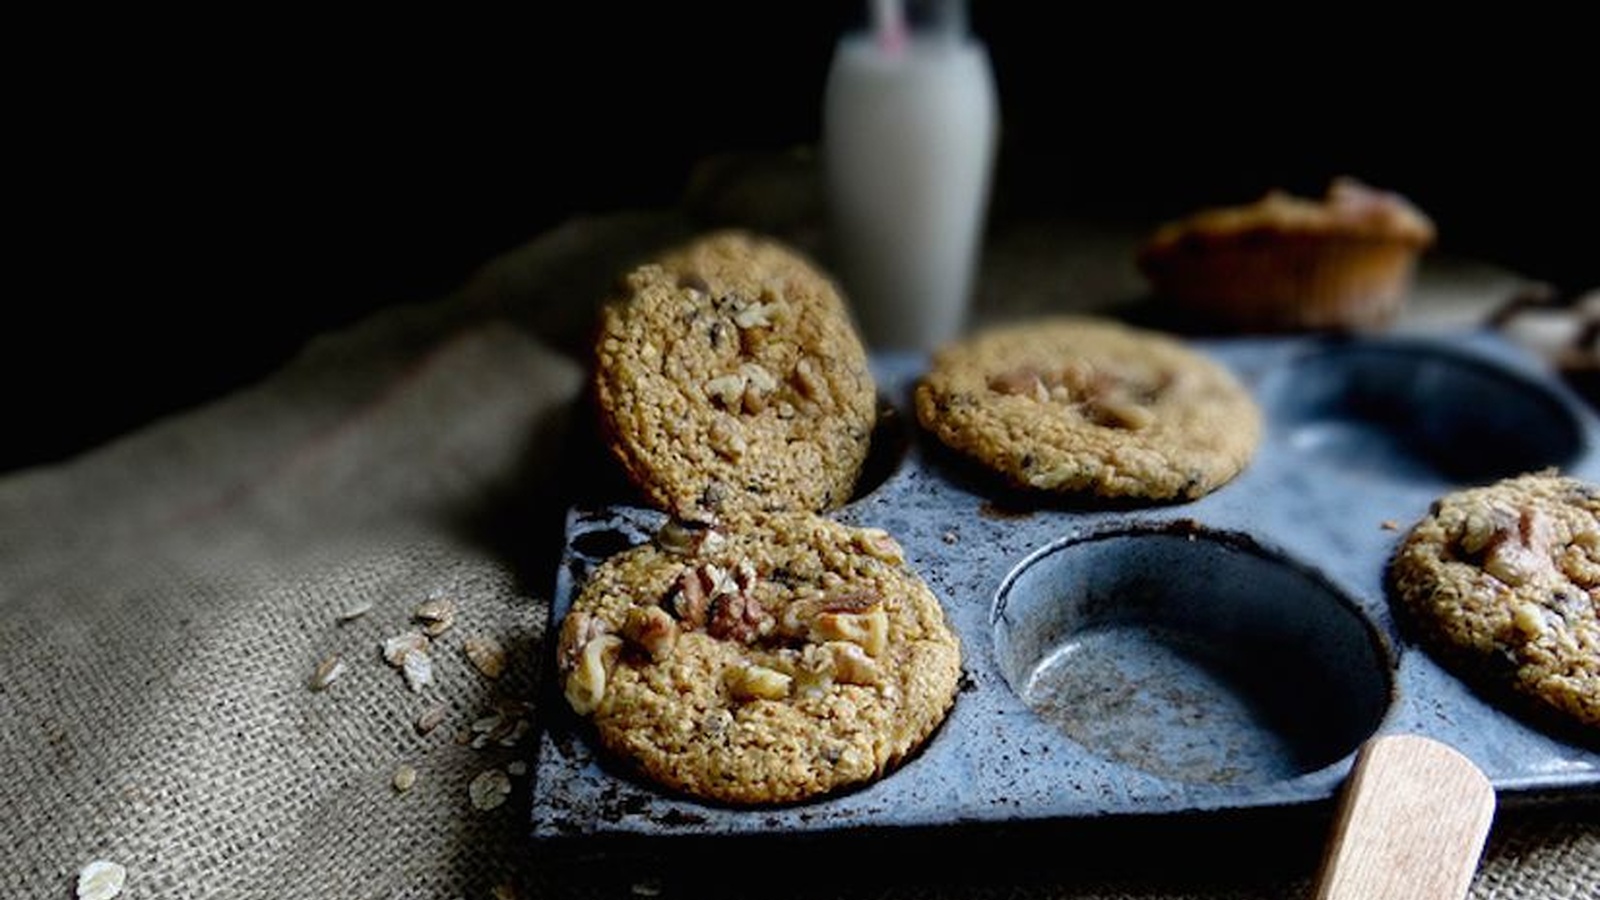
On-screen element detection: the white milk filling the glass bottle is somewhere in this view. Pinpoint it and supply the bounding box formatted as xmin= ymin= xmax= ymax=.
xmin=822 ymin=34 xmax=998 ymax=351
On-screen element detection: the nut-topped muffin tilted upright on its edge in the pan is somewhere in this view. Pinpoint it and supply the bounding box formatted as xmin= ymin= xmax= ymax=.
xmin=594 ymin=231 xmax=877 ymax=520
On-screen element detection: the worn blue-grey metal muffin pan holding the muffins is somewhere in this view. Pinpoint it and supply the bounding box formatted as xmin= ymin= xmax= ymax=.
xmin=531 ymin=331 xmax=1600 ymax=844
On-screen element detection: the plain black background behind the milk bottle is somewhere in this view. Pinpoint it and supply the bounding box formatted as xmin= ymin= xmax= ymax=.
xmin=0 ymin=0 xmax=1600 ymax=469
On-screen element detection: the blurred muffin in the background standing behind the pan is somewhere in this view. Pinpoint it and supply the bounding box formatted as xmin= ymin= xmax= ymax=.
xmin=1136 ymin=176 xmax=1435 ymax=331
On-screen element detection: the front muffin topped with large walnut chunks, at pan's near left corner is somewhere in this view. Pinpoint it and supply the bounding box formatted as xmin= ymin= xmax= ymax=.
xmin=557 ymin=512 xmax=960 ymax=804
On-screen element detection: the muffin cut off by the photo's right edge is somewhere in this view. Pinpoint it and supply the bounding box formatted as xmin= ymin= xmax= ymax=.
xmin=1389 ymin=471 xmax=1600 ymax=729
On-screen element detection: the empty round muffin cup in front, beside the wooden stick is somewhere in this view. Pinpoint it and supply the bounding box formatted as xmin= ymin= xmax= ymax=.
xmin=992 ymin=520 xmax=1394 ymax=785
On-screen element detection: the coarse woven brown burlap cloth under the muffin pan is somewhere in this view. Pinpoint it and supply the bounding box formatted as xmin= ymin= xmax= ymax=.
xmin=0 ymin=192 xmax=1600 ymax=900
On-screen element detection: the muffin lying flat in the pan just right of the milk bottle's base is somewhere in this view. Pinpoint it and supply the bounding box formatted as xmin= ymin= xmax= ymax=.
xmin=915 ymin=315 xmax=1261 ymax=500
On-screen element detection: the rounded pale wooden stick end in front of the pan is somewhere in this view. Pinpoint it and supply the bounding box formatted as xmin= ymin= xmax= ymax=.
xmin=1315 ymin=735 xmax=1494 ymax=900
